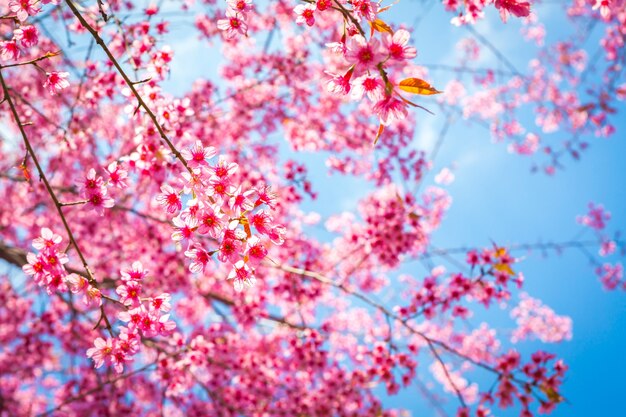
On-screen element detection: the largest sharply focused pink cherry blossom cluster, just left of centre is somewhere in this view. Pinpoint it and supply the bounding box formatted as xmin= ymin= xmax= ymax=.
xmin=157 ymin=141 xmax=286 ymax=291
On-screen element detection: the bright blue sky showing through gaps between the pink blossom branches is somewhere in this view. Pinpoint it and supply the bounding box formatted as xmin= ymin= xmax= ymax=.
xmin=30 ymin=0 xmax=626 ymax=417
